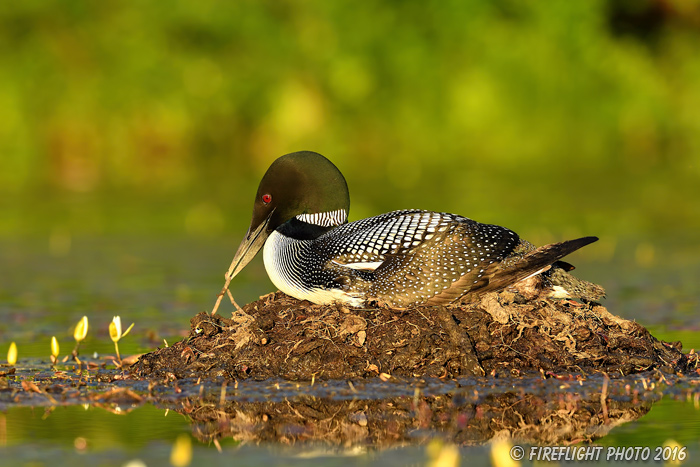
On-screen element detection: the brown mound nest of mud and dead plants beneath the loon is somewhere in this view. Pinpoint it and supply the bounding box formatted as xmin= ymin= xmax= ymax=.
xmin=130 ymin=292 xmax=697 ymax=380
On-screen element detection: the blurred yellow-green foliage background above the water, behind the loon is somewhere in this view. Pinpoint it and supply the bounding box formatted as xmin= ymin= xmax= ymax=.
xmin=0 ymin=0 xmax=700 ymax=256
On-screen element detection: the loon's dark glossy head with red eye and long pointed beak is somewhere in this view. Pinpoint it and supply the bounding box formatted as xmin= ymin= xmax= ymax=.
xmin=227 ymin=151 xmax=350 ymax=279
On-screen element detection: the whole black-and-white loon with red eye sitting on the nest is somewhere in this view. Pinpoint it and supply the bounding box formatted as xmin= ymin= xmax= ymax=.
xmin=223 ymin=151 xmax=598 ymax=308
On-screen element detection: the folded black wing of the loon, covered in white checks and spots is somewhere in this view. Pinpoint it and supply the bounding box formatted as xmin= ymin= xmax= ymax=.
xmin=317 ymin=210 xmax=520 ymax=306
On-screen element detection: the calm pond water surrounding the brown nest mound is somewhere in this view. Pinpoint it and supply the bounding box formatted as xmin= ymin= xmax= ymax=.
xmin=0 ymin=237 xmax=700 ymax=466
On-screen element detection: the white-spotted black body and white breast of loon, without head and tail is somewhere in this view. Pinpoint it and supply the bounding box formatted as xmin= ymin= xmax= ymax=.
xmin=264 ymin=210 xmax=520 ymax=306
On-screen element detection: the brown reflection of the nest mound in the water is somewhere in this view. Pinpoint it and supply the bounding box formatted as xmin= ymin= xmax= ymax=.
xmin=157 ymin=378 xmax=660 ymax=448
